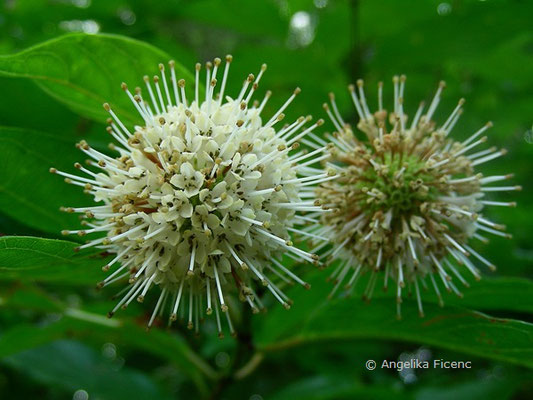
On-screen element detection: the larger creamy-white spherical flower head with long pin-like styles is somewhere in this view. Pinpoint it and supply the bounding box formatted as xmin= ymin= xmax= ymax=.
xmin=52 ymin=56 xmax=326 ymax=335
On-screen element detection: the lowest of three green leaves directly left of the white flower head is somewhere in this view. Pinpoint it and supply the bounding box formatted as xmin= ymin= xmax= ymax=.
xmin=0 ymin=236 xmax=106 ymax=285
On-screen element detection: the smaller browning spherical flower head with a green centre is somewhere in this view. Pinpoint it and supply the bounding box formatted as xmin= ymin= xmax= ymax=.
xmin=317 ymin=76 xmax=520 ymax=317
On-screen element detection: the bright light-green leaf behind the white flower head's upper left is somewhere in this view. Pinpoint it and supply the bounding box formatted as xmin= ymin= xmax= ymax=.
xmin=0 ymin=34 xmax=193 ymax=124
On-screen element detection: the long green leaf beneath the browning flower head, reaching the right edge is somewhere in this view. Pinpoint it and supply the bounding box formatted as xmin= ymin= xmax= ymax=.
xmin=255 ymin=274 xmax=533 ymax=367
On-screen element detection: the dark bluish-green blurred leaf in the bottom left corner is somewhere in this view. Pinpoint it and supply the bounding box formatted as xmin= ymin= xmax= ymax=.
xmin=2 ymin=340 xmax=172 ymax=400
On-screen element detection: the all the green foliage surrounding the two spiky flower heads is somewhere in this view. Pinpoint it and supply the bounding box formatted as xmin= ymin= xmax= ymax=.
xmin=0 ymin=0 xmax=533 ymax=400
